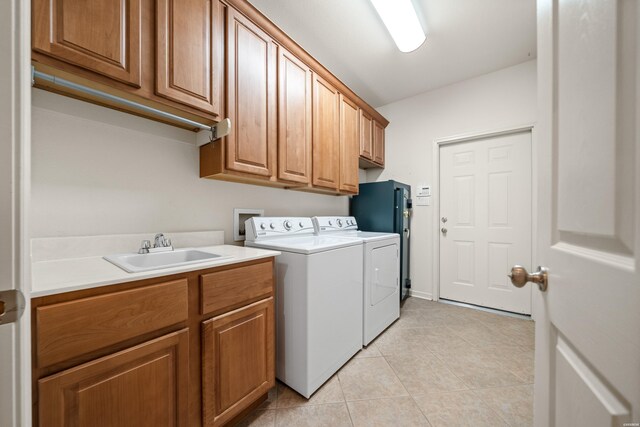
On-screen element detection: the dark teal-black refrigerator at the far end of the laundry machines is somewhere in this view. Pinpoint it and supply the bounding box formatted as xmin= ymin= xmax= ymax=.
xmin=349 ymin=181 xmax=411 ymax=300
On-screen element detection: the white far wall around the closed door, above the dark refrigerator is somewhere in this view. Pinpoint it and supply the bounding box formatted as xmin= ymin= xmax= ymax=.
xmin=367 ymin=60 xmax=536 ymax=298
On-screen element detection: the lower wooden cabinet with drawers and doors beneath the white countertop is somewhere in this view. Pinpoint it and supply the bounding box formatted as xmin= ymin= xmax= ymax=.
xmin=31 ymin=257 xmax=275 ymax=427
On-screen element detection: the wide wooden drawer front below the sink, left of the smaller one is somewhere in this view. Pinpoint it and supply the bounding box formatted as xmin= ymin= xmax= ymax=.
xmin=36 ymin=279 xmax=188 ymax=368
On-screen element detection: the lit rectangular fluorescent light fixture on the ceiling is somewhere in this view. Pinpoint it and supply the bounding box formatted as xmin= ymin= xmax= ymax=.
xmin=371 ymin=0 xmax=427 ymax=52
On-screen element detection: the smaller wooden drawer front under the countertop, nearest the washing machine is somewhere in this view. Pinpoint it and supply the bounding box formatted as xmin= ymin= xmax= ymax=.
xmin=200 ymin=261 xmax=273 ymax=314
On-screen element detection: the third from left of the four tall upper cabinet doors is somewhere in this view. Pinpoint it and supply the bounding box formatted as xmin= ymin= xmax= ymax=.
xmin=313 ymin=74 xmax=340 ymax=189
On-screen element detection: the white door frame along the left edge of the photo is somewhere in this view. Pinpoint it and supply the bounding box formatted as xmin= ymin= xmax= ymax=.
xmin=0 ymin=0 xmax=33 ymax=426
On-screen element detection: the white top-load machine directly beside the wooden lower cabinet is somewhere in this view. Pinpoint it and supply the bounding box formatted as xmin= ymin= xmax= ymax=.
xmin=245 ymin=217 xmax=363 ymax=398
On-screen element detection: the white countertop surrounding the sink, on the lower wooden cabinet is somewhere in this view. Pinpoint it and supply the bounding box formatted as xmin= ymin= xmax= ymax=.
xmin=31 ymin=245 xmax=280 ymax=298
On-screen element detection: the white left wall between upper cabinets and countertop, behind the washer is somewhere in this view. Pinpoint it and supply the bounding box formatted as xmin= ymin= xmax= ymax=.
xmin=31 ymin=89 xmax=348 ymax=243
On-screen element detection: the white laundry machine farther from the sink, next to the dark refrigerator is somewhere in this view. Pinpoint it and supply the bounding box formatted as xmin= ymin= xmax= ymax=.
xmin=312 ymin=216 xmax=400 ymax=346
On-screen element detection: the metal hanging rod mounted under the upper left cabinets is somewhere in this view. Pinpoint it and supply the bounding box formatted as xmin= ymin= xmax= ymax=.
xmin=31 ymin=66 xmax=231 ymax=145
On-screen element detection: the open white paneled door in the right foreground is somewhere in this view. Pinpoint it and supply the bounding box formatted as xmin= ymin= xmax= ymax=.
xmin=534 ymin=0 xmax=640 ymax=427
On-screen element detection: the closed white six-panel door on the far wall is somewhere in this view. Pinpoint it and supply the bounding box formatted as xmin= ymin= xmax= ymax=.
xmin=440 ymin=131 xmax=531 ymax=314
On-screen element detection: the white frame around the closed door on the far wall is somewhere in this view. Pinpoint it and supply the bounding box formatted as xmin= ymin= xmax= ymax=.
xmin=431 ymin=123 xmax=538 ymax=319
